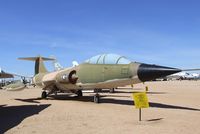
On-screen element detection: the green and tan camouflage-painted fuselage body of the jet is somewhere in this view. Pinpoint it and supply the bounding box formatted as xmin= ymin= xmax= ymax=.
xmin=33 ymin=62 xmax=141 ymax=90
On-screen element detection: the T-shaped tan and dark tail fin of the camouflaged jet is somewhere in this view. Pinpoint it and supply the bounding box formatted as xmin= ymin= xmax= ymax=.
xmin=18 ymin=56 xmax=55 ymax=75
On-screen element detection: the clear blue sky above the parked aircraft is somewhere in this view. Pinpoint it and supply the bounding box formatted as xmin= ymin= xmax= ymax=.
xmin=0 ymin=0 xmax=200 ymax=75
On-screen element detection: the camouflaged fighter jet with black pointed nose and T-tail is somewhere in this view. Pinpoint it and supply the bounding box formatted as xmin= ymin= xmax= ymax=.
xmin=19 ymin=54 xmax=198 ymax=103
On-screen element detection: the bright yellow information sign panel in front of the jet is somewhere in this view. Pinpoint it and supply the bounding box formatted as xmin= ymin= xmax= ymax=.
xmin=133 ymin=92 xmax=149 ymax=108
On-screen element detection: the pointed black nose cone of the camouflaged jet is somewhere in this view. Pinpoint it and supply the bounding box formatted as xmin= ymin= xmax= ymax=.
xmin=137 ymin=64 xmax=181 ymax=82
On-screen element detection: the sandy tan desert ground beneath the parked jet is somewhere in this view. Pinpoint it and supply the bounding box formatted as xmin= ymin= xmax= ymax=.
xmin=0 ymin=81 xmax=200 ymax=134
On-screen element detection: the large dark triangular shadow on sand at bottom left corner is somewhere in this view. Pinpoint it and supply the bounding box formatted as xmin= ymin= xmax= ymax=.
xmin=0 ymin=104 xmax=50 ymax=133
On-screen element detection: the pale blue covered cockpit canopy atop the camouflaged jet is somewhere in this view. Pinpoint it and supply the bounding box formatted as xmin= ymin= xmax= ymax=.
xmin=85 ymin=54 xmax=131 ymax=64
